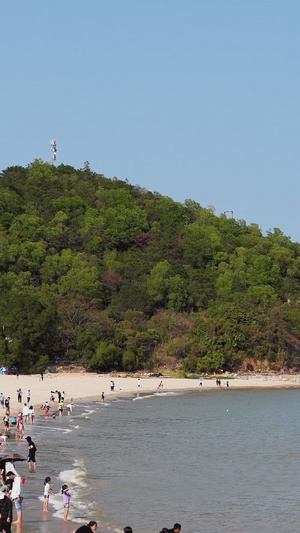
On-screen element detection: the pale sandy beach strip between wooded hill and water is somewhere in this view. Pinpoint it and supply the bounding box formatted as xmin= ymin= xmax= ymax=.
xmin=0 ymin=372 xmax=300 ymax=415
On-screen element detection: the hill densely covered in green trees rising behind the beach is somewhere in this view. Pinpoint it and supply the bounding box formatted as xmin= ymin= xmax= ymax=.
xmin=0 ymin=161 xmax=300 ymax=373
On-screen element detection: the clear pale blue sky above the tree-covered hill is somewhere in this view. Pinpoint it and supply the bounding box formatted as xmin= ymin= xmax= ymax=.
xmin=0 ymin=0 xmax=300 ymax=241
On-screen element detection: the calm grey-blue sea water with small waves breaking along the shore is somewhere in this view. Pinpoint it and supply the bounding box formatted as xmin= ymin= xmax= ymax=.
xmin=7 ymin=388 xmax=300 ymax=533
